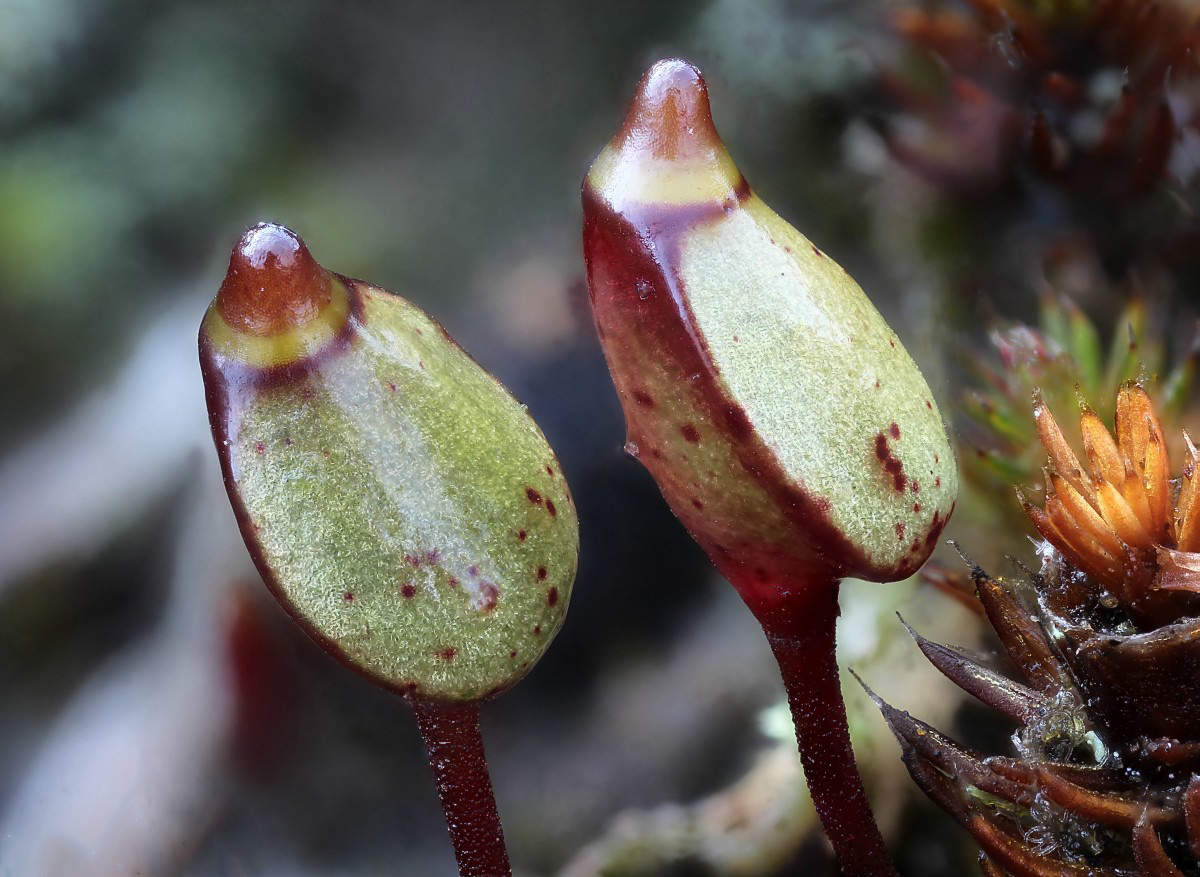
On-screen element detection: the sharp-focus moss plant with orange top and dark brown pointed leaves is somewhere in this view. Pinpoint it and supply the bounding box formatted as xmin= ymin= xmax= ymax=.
xmin=876 ymin=383 xmax=1200 ymax=877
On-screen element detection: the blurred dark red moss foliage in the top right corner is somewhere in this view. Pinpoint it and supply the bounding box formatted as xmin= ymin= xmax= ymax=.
xmin=877 ymin=0 xmax=1200 ymax=298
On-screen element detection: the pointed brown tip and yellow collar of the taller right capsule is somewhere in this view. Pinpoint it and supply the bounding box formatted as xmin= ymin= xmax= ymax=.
xmin=587 ymin=58 xmax=745 ymax=210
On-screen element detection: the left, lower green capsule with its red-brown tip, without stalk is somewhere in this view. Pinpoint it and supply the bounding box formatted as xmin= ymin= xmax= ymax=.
xmin=200 ymin=224 xmax=578 ymax=702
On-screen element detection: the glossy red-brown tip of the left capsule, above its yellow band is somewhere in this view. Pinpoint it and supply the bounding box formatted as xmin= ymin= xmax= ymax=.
xmin=216 ymin=222 xmax=332 ymax=337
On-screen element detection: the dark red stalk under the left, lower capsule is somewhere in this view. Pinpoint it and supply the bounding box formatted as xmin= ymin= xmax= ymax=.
xmin=412 ymin=699 xmax=512 ymax=877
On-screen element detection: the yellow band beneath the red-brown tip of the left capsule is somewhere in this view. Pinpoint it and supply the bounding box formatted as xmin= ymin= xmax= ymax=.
xmin=204 ymin=277 xmax=350 ymax=368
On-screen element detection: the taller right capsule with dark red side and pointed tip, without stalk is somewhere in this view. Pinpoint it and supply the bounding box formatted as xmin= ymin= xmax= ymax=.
xmin=583 ymin=59 xmax=958 ymax=607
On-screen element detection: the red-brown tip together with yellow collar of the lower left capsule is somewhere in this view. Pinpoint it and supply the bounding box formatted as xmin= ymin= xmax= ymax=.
xmin=203 ymin=222 xmax=349 ymax=368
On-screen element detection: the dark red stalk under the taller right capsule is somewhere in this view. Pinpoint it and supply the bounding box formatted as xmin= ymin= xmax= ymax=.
xmin=758 ymin=582 xmax=896 ymax=877
